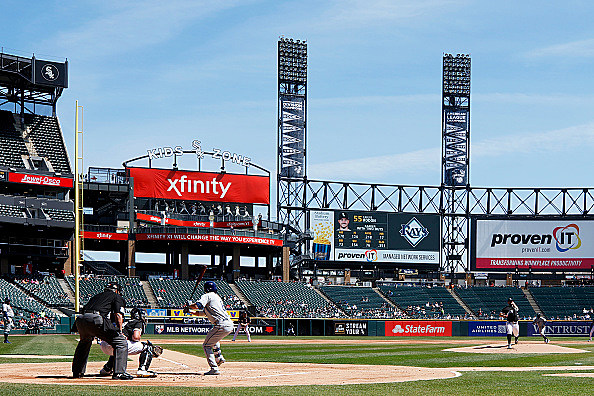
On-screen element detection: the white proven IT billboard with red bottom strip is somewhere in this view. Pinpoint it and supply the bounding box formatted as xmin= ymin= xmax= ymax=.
xmin=471 ymin=219 xmax=594 ymax=271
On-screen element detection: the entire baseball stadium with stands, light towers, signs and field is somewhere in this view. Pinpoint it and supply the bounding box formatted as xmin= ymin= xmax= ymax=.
xmin=0 ymin=37 xmax=594 ymax=395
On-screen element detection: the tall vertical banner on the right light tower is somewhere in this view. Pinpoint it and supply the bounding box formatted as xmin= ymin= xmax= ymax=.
xmin=443 ymin=109 xmax=470 ymax=186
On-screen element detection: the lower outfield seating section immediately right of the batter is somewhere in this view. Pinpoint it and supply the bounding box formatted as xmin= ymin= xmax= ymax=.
xmin=236 ymin=280 xmax=344 ymax=318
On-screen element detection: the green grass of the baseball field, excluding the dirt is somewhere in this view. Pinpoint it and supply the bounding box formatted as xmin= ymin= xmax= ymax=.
xmin=0 ymin=335 xmax=594 ymax=396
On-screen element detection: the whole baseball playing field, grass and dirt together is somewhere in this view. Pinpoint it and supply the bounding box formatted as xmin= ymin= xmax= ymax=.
xmin=0 ymin=335 xmax=594 ymax=396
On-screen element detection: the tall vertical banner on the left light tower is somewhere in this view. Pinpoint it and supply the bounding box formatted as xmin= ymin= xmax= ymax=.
xmin=279 ymin=95 xmax=305 ymax=177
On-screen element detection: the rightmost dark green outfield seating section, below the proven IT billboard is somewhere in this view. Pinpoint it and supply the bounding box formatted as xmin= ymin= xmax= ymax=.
xmin=529 ymin=286 xmax=594 ymax=319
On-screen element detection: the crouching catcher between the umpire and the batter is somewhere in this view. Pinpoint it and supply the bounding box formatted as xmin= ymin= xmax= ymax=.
xmin=99 ymin=308 xmax=163 ymax=378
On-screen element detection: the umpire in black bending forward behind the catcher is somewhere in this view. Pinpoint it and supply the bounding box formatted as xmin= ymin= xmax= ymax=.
xmin=72 ymin=282 xmax=134 ymax=380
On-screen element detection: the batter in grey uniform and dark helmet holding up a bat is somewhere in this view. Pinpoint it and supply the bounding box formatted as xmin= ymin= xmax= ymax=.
xmin=186 ymin=281 xmax=233 ymax=375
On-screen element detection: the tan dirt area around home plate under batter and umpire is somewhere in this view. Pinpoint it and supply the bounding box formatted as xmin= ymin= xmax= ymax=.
xmin=0 ymin=350 xmax=460 ymax=387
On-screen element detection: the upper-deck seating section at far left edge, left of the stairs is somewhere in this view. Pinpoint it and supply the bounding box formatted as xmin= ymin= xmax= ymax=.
xmin=0 ymin=110 xmax=29 ymax=169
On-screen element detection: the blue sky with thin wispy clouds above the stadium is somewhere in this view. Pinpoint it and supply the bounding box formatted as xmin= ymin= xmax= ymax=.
xmin=0 ymin=0 xmax=594 ymax=197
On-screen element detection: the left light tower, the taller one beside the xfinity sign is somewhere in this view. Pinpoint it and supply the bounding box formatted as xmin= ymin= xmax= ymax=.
xmin=276 ymin=37 xmax=307 ymax=229
